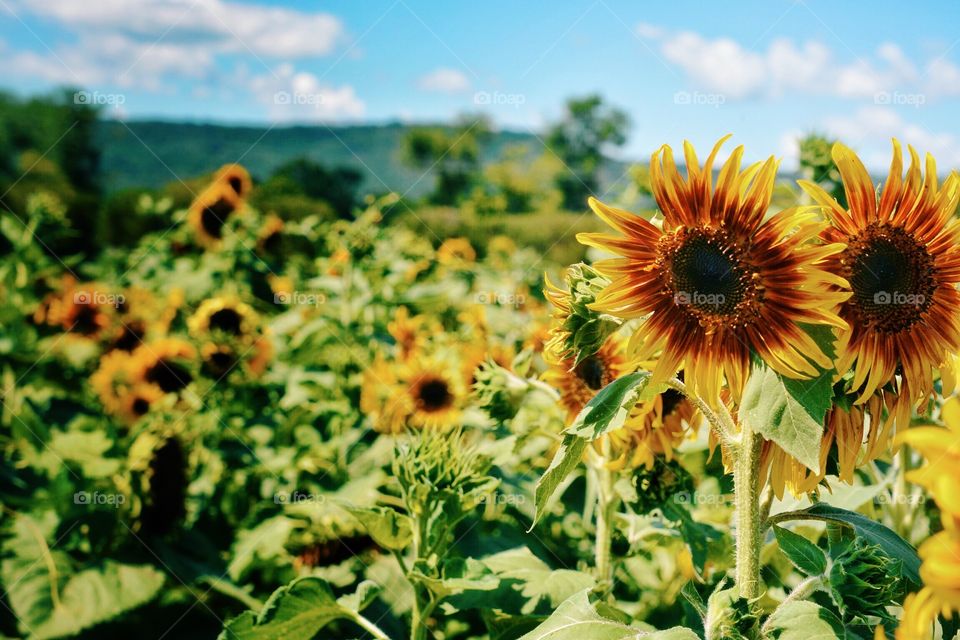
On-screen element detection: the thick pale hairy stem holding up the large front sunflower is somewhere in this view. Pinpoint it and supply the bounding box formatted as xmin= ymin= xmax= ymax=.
xmin=733 ymin=424 xmax=763 ymax=600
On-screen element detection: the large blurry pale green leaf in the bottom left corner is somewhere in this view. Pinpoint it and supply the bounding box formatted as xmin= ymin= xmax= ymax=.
xmin=0 ymin=514 xmax=164 ymax=640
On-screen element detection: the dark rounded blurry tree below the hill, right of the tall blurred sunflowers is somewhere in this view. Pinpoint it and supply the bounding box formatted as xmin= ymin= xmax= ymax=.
xmin=258 ymin=158 xmax=363 ymax=218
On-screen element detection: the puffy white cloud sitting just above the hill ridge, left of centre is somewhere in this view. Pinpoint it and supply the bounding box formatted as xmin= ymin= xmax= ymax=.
xmin=249 ymin=64 xmax=366 ymax=122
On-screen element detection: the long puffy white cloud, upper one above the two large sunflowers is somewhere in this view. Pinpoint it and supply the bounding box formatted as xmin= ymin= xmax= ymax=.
xmin=637 ymin=24 xmax=948 ymax=99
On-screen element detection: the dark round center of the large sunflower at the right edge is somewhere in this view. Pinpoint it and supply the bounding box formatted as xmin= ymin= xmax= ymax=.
xmin=843 ymin=225 xmax=937 ymax=333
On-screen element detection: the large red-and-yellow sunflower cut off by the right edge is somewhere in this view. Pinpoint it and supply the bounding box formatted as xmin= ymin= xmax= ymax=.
xmin=801 ymin=140 xmax=960 ymax=424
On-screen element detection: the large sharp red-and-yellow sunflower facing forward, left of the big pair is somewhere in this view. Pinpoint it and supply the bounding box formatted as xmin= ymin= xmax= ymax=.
xmin=577 ymin=138 xmax=847 ymax=399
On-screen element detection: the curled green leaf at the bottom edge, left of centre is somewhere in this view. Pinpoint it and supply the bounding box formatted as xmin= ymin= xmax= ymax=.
xmin=218 ymin=576 xmax=370 ymax=640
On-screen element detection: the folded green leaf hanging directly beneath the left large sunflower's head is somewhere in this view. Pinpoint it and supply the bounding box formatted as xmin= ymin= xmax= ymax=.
xmin=740 ymin=365 xmax=833 ymax=471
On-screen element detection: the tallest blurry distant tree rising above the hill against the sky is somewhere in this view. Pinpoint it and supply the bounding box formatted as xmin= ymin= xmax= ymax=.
xmin=547 ymin=95 xmax=630 ymax=209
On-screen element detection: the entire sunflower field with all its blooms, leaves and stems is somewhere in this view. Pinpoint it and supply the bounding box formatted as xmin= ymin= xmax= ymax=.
xmin=0 ymin=131 xmax=960 ymax=640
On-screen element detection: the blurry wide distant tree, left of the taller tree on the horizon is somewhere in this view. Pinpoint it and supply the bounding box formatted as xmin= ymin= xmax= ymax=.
xmin=403 ymin=117 xmax=490 ymax=205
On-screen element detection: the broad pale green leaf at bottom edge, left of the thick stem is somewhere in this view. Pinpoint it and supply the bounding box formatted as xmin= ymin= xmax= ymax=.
xmin=520 ymin=590 xmax=697 ymax=640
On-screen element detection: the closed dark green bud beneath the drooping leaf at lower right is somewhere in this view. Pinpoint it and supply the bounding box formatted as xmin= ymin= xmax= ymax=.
xmin=830 ymin=540 xmax=903 ymax=623
